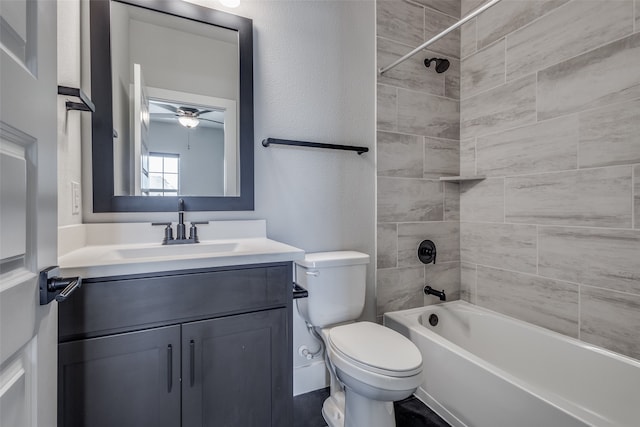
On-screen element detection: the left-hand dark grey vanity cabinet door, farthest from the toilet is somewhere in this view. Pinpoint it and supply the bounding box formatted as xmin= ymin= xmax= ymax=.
xmin=58 ymin=326 xmax=180 ymax=427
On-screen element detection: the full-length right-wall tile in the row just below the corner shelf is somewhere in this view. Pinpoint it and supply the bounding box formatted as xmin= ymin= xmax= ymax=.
xmin=505 ymin=166 xmax=631 ymax=228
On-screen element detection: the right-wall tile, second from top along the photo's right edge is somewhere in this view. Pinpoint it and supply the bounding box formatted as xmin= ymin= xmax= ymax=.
xmin=538 ymin=32 xmax=640 ymax=120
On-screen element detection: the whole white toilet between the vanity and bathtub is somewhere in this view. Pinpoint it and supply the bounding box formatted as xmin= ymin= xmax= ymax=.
xmin=296 ymin=251 xmax=422 ymax=427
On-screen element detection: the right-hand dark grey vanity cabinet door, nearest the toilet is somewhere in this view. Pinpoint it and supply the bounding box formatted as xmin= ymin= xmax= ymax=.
xmin=182 ymin=309 xmax=292 ymax=427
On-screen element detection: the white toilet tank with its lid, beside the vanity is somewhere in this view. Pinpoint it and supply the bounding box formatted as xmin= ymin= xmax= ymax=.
xmin=295 ymin=251 xmax=369 ymax=328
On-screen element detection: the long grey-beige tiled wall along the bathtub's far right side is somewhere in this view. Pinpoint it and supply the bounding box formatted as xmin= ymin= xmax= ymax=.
xmin=460 ymin=0 xmax=640 ymax=358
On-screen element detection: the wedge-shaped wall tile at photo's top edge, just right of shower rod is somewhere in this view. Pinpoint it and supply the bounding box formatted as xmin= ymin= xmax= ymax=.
xmin=477 ymin=0 xmax=569 ymax=47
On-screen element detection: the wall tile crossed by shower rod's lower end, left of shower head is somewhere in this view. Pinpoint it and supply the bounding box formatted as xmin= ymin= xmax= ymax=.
xmin=377 ymin=37 xmax=445 ymax=96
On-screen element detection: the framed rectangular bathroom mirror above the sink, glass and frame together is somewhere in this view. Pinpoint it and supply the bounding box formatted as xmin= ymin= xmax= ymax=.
xmin=90 ymin=0 xmax=254 ymax=212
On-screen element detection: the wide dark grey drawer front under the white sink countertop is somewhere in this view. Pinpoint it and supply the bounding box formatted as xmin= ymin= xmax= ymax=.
xmin=59 ymin=263 xmax=291 ymax=342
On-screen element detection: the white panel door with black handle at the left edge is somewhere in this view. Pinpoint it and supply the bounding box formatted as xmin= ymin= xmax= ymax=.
xmin=0 ymin=0 xmax=58 ymax=427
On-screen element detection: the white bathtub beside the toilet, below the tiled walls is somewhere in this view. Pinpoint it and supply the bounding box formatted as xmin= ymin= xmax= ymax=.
xmin=384 ymin=301 xmax=640 ymax=427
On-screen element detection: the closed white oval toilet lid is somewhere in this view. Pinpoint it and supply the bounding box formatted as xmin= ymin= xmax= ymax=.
xmin=329 ymin=322 xmax=422 ymax=374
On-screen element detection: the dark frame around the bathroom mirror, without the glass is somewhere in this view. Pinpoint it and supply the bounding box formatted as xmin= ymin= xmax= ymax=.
xmin=89 ymin=0 xmax=254 ymax=212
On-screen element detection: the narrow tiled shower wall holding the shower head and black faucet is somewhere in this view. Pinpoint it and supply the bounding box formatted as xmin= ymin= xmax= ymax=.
xmin=376 ymin=0 xmax=460 ymax=316
